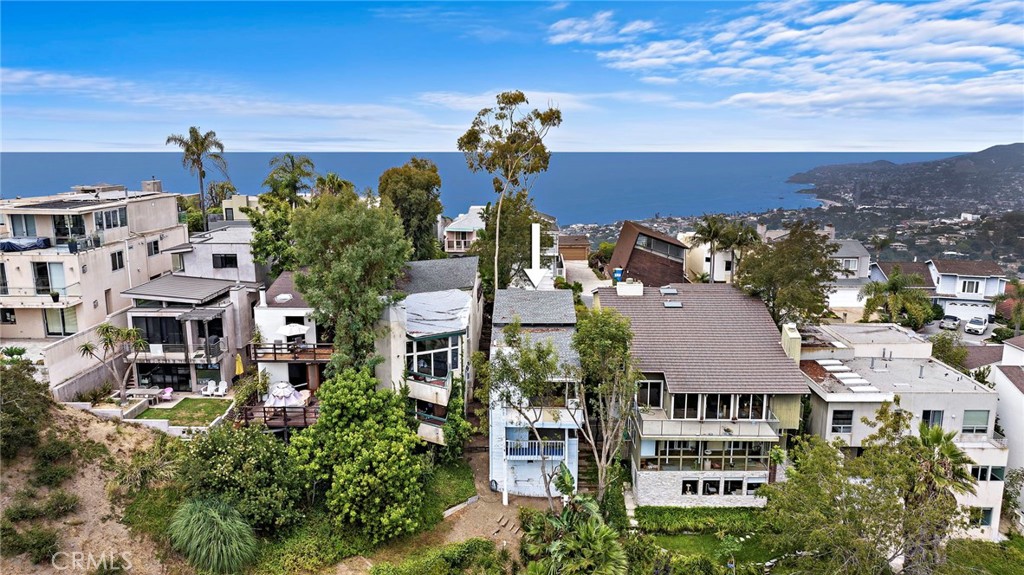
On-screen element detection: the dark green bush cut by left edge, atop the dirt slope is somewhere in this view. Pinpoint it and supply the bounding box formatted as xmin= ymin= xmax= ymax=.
xmin=0 ymin=361 xmax=53 ymax=461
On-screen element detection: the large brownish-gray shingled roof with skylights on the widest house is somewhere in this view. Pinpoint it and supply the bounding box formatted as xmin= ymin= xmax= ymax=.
xmin=597 ymin=283 xmax=808 ymax=394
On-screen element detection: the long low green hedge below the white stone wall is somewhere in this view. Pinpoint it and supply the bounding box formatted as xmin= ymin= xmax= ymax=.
xmin=635 ymin=507 xmax=761 ymax=535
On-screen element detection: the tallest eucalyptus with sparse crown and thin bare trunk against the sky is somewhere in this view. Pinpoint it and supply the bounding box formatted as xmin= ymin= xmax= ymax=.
xmin=458 ymin=90 xmax=562 ymax=293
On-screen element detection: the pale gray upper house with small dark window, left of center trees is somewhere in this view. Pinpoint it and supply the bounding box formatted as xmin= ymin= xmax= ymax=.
xmin=164 ymin=225 xmax=270 ymax=283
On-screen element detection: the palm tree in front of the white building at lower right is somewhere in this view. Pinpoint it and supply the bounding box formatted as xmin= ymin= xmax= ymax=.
xmin=903 ymin=415 xmax=976 ymax=575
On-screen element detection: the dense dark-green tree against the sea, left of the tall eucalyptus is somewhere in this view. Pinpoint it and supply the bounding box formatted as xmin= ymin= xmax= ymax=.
xmin=377 ymin=158 xmax=442 ymax=260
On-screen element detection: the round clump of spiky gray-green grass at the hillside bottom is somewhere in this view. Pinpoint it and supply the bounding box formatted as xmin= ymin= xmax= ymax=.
xmin=167 ymin=499 xmax=257 ymax=574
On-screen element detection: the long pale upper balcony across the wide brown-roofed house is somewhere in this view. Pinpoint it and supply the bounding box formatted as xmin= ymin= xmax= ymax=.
xmin=634 ymin=405 xmax=778 ymax=441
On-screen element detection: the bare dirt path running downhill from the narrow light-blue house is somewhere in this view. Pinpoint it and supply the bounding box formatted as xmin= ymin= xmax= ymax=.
xmin=335 ymin=452 xmax=547 ymax=575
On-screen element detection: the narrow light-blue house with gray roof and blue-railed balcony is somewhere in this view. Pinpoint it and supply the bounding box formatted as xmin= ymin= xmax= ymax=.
xmin=487 ymin=290 xmax=583 ymax=504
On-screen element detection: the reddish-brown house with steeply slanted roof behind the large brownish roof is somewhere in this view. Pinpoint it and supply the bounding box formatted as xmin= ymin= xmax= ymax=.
xmin=604 ymin=220 xmax=689 ymax=285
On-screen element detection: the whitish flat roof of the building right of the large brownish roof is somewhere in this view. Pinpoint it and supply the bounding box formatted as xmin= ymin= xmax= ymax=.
xmin=800 ymin=357 xmax=995 ymax=397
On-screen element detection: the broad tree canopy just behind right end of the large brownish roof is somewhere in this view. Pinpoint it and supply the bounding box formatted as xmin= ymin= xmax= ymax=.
xmin=735 ymin=220 xmax=842 ymax=325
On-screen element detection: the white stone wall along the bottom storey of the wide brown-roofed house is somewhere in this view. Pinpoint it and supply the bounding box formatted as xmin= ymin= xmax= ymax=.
xmin=633 ymin=470 xmax=768 ymax=507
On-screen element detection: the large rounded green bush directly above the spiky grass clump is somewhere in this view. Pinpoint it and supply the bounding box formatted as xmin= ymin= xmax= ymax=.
xmin=180 ymin=426 xmax=302 ymax=530
